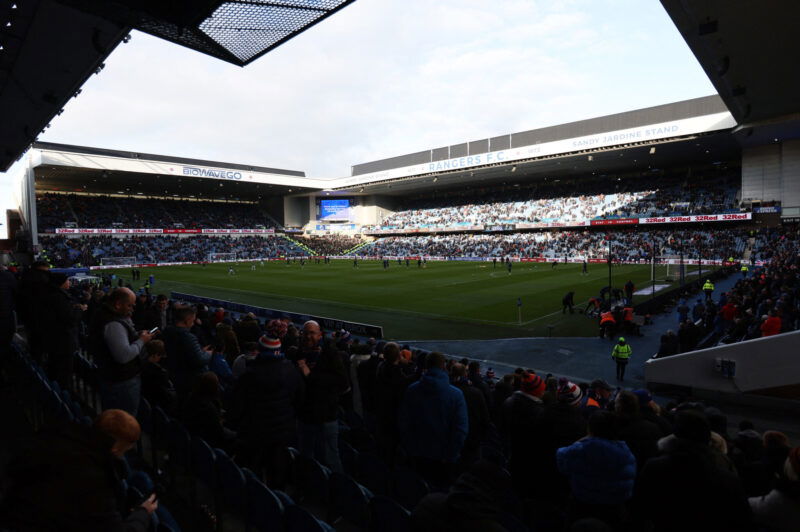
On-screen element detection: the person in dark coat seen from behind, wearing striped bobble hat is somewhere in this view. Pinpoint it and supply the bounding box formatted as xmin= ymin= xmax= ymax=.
xmin=233 ymin=339 xmax=305 ymax=489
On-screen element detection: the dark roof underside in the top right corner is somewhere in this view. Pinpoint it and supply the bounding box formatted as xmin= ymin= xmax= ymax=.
xmin=661 ymin=0 xmax=800 ymax=125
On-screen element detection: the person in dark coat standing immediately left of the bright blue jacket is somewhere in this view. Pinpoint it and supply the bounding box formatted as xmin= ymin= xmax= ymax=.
xmin=374 ymin=342 xmax=413 ymax=464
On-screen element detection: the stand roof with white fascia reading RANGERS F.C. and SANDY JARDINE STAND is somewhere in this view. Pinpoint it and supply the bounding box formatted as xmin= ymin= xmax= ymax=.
xmin=335 ymin=96 xmax=739 ymax=193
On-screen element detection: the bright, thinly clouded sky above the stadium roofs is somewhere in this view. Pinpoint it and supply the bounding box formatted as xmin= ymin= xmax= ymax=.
xmin=0 ymin=0 xmax=715 ymax=238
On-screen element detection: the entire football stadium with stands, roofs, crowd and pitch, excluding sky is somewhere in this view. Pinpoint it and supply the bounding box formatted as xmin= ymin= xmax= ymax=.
xmin=0 ymin=0 xmax=800 ymax=532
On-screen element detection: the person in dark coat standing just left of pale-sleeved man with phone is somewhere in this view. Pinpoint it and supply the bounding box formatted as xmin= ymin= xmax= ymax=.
xmin=43 ymin=273 xmax=86 ymax=389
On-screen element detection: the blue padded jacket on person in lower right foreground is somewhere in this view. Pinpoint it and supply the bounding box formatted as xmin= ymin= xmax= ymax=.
xmin=556 ymin=437 xmax=636 ymax=504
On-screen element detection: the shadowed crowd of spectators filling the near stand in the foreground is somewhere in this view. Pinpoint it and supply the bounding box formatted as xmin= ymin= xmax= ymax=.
xmin=0 ymin=262 xmax=800 ymax=532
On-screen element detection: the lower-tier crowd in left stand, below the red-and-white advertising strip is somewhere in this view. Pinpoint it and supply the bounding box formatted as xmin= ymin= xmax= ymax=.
xmin=39 ymin=235 xmax=306 ymax=268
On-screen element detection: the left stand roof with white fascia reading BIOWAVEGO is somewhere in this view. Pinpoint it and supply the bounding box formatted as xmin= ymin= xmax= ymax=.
xmin=31 ymin=142 xmax=322 ymax=201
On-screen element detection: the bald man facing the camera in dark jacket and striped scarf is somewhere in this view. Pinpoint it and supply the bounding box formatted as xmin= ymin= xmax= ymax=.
xmin=297 ymin=332 xmax=348 ymax=473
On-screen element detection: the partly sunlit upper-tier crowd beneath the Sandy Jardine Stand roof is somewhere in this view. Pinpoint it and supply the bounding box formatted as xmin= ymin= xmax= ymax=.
xmin=367 ymin=174 xmax=740 ymax=229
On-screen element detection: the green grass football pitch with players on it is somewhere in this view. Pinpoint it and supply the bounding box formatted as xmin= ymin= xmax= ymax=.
xmin=131 ymin=260 xmax=692 ymax=341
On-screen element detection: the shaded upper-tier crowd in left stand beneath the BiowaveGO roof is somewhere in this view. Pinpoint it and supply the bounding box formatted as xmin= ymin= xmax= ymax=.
xmin=36 ymin=194 xmax=275 ymax=232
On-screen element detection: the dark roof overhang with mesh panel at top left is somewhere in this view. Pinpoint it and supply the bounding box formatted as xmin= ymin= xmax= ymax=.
xmin=0 ymin=0 xmax=355 ymax=171
